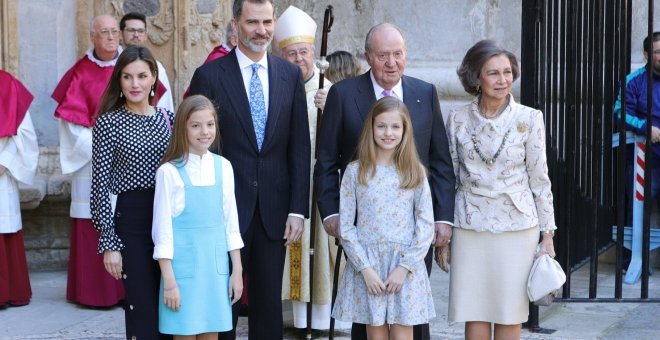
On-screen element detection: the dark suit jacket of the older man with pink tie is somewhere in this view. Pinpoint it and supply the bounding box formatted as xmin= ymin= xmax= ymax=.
xmin=314 ymin=71 xmax=456 ymax=222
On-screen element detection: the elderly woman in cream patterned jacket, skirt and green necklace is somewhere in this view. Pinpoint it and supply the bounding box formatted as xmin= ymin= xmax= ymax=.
xmin=447 ymin=40 xmax=556 ymax=339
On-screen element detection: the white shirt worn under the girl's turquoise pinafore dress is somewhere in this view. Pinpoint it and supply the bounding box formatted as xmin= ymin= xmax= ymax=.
xmin=151 ymin=152 xmax=243 ymax=260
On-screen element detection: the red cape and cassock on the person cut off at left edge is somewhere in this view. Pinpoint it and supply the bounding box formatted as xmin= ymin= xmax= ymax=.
xmin=0 ymin=70 xmax=33 ymax=306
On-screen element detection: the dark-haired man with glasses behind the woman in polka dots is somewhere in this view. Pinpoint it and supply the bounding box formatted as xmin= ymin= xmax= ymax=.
xmin=119 ymin=12 xmax=176 ymax=112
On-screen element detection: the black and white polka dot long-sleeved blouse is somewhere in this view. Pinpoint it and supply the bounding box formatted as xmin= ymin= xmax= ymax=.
xmin=90 ymin=107 xmax=174 ymax=254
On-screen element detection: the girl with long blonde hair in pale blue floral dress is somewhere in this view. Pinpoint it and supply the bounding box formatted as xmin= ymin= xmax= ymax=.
xmin=332 ymin=97 xmax=435 ymax=339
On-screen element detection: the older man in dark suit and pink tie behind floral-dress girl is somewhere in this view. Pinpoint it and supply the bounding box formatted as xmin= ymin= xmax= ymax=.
xmin=314 ymin=23 xmax=455 ymax=339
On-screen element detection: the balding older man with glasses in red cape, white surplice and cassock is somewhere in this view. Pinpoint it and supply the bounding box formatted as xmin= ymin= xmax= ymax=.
xmin=52 ymin=15 xmax=124 ymax=307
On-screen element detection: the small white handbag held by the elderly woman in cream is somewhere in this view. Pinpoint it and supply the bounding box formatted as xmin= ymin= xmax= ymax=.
xmin=527 ymin=254 xmax=566 ymax=306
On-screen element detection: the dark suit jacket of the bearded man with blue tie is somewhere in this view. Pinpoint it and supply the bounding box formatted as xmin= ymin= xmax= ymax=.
xmin=190 ymin=50 xmax=311 ymax=240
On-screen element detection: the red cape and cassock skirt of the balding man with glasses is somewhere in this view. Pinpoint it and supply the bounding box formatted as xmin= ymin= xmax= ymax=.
xmin=52 ymin=56 xmax=124 ymax=307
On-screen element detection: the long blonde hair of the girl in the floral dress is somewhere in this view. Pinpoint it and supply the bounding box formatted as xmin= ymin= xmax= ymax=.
xmin=357 ymin=97 xmax=426 ymax=189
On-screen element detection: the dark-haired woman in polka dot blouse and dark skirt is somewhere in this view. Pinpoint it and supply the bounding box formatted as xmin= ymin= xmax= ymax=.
xmin=91 ymin=46 xmax=174 ymax=339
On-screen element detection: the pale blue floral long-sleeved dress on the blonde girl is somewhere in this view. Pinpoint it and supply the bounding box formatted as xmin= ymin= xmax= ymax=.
xmin=332 ymin=162 xmax=435 ymax=326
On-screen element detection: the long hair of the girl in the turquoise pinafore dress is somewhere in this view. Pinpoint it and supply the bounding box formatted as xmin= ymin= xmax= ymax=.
xmin=160 ymin=94 xmax=220 ymax=165
